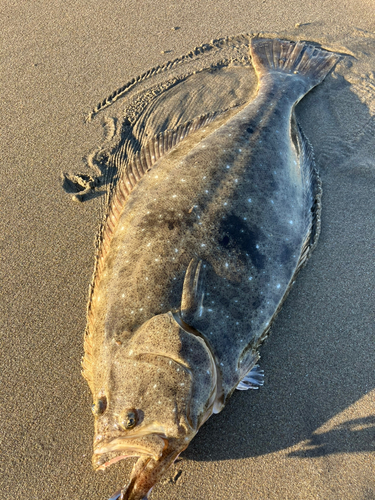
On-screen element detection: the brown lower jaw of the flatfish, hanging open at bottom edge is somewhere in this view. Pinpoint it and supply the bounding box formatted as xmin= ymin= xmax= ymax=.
xmin=118 ymin=437 xmax=192 ymax=500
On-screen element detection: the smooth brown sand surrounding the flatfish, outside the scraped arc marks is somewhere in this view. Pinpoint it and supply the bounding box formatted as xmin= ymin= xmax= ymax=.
xmin=0 ymin=0 xmax=375 ymax=500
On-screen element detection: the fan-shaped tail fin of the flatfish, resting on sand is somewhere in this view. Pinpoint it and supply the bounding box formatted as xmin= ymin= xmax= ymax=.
xmin=250 ymin=38 xmax=340 ymax=90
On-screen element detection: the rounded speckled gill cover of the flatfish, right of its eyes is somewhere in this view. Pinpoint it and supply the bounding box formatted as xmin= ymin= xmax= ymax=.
xmin=126 ymin=312 xmax=216 ymax=431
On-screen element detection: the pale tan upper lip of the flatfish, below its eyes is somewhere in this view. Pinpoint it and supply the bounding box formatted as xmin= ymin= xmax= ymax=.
xmin=92 ymin=434 xmax=168 ymax=470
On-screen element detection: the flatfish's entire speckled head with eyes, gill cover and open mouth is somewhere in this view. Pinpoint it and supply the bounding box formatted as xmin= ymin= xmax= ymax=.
xmin=93 ymin=313 xmax=217 ymax=500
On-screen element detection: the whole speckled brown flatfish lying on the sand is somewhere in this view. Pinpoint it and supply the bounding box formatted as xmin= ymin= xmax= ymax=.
xmin=82 ymin=37 xmax=339 ymax=500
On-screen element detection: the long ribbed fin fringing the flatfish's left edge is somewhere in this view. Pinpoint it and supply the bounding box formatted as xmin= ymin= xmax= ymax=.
xmin=82 ymin=113 xmax=218 ymax=385
